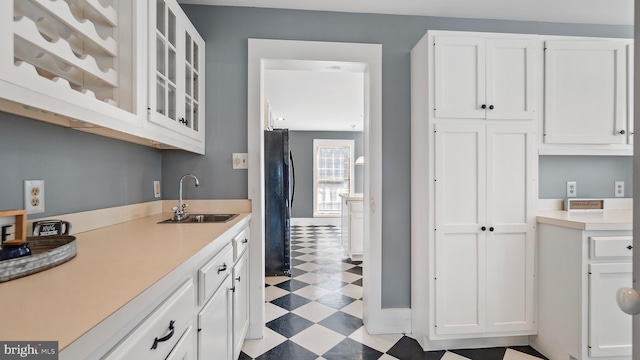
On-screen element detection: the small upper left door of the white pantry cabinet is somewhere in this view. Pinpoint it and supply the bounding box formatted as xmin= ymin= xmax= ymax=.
xmin=433 ymin=36 xmax=486 ymax=119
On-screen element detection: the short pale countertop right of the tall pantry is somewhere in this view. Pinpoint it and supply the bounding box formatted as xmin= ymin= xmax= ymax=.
xmin=536 ymin=209 xmax=633 ymax=230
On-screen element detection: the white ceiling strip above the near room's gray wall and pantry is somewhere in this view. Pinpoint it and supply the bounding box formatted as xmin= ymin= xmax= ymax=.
xmin=178 ymin=0 xmax=634 ymax=25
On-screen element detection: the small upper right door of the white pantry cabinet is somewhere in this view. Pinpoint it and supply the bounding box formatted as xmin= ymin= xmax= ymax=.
xmin=486 ymin=39 xmax=538 ymax=120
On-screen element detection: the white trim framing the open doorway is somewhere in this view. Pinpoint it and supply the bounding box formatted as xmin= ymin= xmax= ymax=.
xmin=247 ymin=39 xmax=385 ymax=339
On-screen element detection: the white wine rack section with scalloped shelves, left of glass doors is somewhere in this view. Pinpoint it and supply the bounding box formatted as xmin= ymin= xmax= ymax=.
xmin=0 ymin=0 xmax=146 ymax=130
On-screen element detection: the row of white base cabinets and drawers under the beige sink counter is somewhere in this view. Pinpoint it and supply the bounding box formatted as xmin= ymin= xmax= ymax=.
xmin=94 ymin=225 xmax=250 ymax=360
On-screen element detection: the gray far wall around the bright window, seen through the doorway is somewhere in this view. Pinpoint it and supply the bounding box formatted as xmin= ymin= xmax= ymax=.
xmin=289 ymin=131 xmax=364 ymax=218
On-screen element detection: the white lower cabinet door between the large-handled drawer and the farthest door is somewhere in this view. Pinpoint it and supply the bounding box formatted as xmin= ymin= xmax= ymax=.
xmin=198 ymin=276 xmax=233 ymax=360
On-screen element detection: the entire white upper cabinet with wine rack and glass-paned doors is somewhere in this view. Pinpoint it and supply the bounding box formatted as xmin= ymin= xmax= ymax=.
xmin=0 ymin=0 xmax=204 ymax=153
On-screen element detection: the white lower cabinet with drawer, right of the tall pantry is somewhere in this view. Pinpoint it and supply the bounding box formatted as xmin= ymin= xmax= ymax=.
xmin=532 ymin=224 xmax=632 ymax=360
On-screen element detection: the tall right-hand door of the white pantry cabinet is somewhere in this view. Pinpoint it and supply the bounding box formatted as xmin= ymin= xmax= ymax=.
xmin=486 ymin=124 xmax=537 ymax=332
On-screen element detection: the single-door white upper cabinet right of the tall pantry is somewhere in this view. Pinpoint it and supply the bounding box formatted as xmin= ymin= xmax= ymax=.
xmin=544 ymin=40 xmax=628 ymax=144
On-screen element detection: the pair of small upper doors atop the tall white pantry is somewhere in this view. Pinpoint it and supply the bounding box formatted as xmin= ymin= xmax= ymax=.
xmin=433 ymin=35 xmax=537 ymax=120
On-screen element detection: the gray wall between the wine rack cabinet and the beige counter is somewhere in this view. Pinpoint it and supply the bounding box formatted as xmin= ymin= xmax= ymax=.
xmin=0 ymin=112 xmax=162 ymax=218
